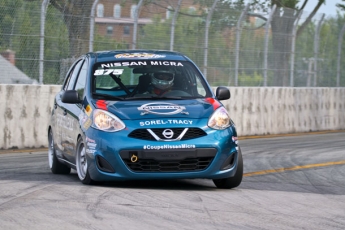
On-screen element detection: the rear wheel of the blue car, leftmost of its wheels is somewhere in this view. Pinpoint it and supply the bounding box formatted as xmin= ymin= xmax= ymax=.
xmin=48 ymin=129 xmax=71 ymax=174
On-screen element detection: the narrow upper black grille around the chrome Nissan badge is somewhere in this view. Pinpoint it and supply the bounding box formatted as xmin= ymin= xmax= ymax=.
xmin=128 ymin=128 xmax=207 ymax=141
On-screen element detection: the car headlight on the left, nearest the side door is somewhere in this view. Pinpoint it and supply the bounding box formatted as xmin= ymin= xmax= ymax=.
xmin=92 ymin=109 xmax=126 ymax=132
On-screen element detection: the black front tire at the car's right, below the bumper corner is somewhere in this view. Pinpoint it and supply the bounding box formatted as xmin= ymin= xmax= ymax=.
xmin=213 ymin=149 xmax=243 ymax=189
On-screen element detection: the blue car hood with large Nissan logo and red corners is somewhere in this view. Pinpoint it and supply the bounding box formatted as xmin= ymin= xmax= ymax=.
xmin=94 ymin=98 xmax=221 ymax=120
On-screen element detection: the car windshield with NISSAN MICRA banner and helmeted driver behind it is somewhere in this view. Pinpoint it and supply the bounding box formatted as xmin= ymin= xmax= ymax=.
xmin=92 ymin=59 xmax=211 ymax=100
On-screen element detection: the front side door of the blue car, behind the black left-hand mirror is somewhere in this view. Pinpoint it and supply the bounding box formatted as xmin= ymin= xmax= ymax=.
xmin=64 ymin=57 xmax=88 ymax=163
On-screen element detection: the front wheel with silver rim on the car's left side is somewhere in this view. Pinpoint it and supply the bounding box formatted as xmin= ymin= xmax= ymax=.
xmin=75 ymin=138 xmax=98 ymax=185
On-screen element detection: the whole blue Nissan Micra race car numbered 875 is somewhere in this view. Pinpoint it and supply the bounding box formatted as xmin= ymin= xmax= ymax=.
xmin=48 ymin=50 xmax=243 ymax=188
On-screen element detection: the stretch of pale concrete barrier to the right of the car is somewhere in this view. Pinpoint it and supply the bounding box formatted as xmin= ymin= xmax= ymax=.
xmin=223 ymin=87 xmax=345 ymax=136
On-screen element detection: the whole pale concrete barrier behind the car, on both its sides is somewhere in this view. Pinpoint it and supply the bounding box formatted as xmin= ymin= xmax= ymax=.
xmin=0 ymin=85 xmax=345 ymax=149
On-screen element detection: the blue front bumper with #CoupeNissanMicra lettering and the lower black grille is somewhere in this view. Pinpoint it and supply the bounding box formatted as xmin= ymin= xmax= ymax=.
xmin=85 ymin=122 xmax=239 ymax=181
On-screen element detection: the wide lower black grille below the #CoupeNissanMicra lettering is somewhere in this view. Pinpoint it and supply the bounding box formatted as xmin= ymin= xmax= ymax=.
xmin=124 ymin=157 xmax=213 ymax=172
